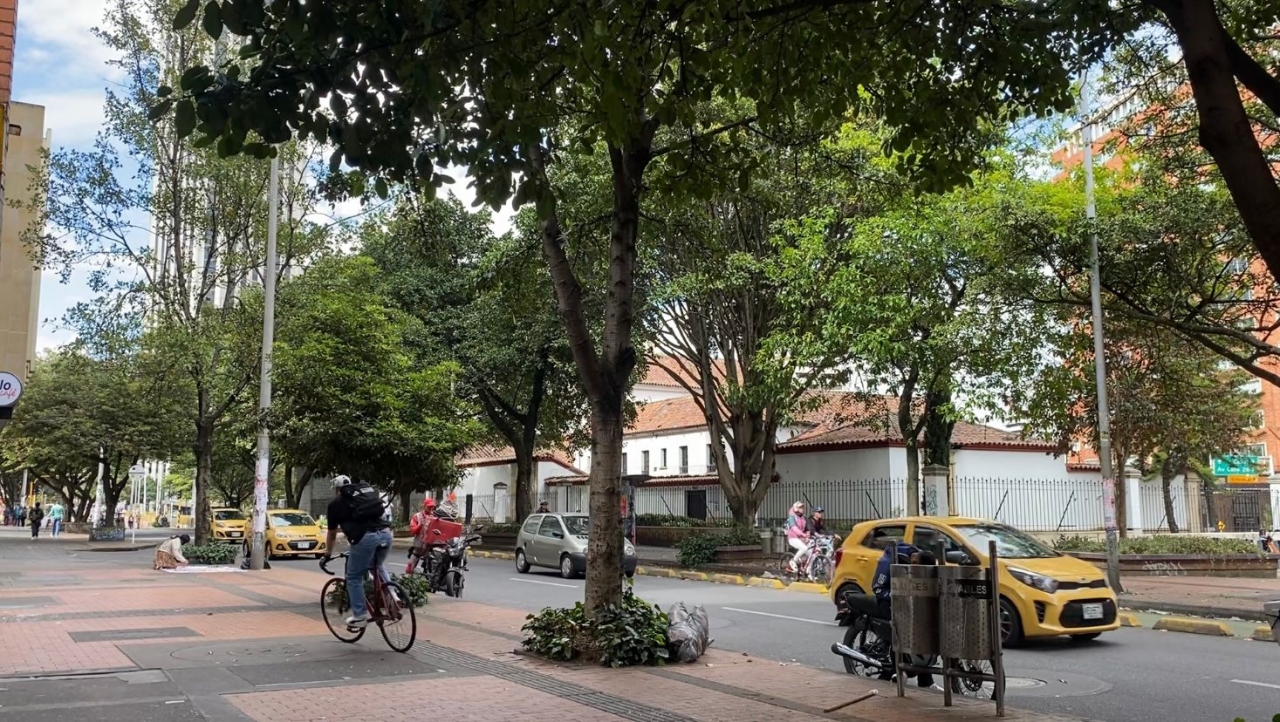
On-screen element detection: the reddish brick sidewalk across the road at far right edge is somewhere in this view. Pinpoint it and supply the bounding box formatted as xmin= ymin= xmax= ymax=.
xmin=1120 ymin=576 xmax=1280 ymax=622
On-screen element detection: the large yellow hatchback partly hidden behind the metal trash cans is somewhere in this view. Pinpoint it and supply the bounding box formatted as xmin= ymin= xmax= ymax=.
xmin=831 ymin=516 xmax=1120 ymax=646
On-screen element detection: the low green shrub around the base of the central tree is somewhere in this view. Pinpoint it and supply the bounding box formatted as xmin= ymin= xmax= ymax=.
xmin=521 ymin=589 xmax=668 ymax=667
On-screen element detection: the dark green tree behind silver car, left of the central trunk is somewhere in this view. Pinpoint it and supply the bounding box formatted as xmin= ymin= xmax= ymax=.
xmin=361 ymin=195 xmax=585 ymax=521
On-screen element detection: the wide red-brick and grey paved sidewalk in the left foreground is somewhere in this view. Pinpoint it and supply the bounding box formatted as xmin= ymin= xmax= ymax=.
xmin=0 ymin=544 xmax=1085 ymax=722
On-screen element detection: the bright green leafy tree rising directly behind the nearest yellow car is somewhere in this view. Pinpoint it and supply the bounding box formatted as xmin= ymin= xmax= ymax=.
xmin=790 ymin=166 xmax=1046 ymax=513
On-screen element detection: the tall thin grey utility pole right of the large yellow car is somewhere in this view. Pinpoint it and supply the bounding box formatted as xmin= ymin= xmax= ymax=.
xmin=1080 ymin=69 xmax=1123 ymax=594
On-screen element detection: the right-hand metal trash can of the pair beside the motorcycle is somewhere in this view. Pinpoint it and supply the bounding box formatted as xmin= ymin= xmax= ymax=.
xmin=938 ymin=566 xmax=995 ymax=659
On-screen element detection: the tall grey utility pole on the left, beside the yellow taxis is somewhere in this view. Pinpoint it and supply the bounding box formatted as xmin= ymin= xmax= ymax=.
xmin=250 ymin=156 xmax=280 ymax=570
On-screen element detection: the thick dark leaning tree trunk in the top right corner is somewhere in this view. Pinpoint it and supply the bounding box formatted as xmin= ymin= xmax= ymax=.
xmin=1147 ymin=0 xmax=1280 ymax=278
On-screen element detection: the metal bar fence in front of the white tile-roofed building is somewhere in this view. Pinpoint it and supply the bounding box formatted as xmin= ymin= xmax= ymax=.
xmin=619 ymin=477 xmax=1208 ymax=534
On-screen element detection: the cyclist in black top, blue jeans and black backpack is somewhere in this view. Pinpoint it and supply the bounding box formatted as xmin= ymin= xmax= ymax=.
xmin=320 ymin=475 xmax=392 ymax=629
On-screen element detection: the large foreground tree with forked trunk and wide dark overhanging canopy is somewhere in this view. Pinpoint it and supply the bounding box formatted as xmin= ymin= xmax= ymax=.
xmin=172 ymin=0 xmax=1121 ymax=614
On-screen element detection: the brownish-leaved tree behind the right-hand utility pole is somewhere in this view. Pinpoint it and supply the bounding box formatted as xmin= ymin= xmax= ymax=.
xmin=1027 ymin=320 xmax=1257 ymax=536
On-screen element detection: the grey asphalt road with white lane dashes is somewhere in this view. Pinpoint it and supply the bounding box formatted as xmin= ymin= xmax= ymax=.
xmin=274 ymin=554 xmax=1280 ymax=722
